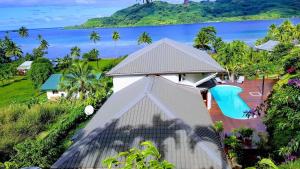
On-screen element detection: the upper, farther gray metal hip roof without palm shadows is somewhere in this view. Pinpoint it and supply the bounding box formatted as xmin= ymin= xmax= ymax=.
xmin=107 ymin=39 xmax=225 ymax=76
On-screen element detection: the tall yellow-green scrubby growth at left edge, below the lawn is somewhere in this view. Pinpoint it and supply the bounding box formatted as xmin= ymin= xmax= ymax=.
xmin=0 ymin=103 xmax=67 ymax=161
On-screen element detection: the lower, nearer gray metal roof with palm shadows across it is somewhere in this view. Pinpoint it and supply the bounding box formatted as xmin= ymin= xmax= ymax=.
xmin=51 ymin=76 xmax=229 ymax=169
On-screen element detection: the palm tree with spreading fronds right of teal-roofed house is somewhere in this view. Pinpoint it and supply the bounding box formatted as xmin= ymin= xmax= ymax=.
xmin=60 ymin=62 xmax=96 ymax=100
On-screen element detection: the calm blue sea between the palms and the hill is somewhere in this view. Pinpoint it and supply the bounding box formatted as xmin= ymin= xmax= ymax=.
xmin=0 ymin=19 xmax=300 ymax=59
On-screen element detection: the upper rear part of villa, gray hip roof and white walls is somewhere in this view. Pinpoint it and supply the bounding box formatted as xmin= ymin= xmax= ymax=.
xmin=107 ymin=39 xmax=225 ymax=109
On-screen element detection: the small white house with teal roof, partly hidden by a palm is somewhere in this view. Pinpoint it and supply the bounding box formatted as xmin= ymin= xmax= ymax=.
xmin=41 ymin=74 xmax=101 ymax=100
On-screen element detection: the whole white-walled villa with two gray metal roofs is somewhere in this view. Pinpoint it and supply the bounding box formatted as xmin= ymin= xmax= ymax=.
xmin=51 ymin=39 xmax=230 ymax=169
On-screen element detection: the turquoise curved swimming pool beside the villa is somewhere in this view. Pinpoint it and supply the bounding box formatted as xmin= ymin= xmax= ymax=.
xmin=210 ymin=85 xmax=250 ymax=119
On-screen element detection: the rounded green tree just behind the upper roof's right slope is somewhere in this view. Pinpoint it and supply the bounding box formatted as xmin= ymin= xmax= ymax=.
xmin=216 ymin=41 xmax=250 ymax=82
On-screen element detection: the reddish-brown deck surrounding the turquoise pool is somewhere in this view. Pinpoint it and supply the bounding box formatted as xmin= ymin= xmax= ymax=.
xmin=209 ymin=79 xmax=276 ymax=133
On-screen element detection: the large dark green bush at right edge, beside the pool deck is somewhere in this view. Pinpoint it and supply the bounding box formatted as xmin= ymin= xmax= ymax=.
xmin=263 ymin=76 xmax=300 ymax=157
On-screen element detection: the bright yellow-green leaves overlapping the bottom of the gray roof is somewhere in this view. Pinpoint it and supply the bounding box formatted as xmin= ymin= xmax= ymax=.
xmin=102 ymin=141 xmax=175 ymax=169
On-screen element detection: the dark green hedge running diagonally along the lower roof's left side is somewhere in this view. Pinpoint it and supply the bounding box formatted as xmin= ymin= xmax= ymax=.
xmin=12 ymin=106 xmax=86 ymax=168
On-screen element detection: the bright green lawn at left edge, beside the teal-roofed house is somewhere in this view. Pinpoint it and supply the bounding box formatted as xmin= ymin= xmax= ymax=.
xmin=0 ymin=77 xmax=44 ymax=108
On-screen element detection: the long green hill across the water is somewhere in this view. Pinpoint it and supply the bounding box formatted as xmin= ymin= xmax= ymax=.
xmin=71 ymin=0 xmax=300 ymax=28
